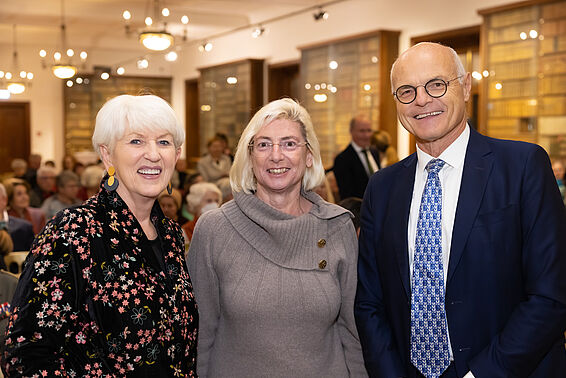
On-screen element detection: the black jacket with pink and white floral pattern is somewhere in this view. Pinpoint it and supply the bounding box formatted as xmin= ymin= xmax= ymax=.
xmin=2 ymin=185 xmax=198 ymax=377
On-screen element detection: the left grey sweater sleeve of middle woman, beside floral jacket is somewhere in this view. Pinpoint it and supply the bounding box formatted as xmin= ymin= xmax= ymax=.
xmin=187 ymin=214 xmax=220 ymax=378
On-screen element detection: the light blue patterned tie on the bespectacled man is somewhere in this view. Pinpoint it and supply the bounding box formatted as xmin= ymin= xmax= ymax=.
xmin=411 ymin=159 xmax=450 ymax=378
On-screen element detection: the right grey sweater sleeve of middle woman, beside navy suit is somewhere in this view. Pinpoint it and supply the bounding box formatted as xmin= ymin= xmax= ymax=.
xmin=338 ymin=217 xmax=368 ymax=377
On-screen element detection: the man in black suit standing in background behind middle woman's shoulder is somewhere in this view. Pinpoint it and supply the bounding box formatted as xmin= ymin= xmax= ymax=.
xmin=333 ymin=116 xmax=379 ymax=199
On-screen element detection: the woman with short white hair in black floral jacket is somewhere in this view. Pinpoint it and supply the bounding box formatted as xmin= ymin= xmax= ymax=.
xmin=2 ymin=95 xmax=198 ymax=377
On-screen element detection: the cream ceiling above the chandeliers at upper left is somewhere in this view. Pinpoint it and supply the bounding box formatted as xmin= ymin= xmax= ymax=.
xmin=0 ymin=0 xmax=330 ymax=52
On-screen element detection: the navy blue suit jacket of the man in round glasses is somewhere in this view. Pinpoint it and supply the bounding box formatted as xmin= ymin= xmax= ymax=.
xmin=354 ymin=130 xmax=566 ymax=378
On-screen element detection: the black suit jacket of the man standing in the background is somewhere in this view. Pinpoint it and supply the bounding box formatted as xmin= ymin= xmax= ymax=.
xmin=332 ymin=143 xmax=380 ymax=199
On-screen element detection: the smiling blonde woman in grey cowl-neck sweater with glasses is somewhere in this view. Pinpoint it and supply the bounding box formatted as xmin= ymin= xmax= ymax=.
xmin=188 ymin=99 xmax=367 ymax=378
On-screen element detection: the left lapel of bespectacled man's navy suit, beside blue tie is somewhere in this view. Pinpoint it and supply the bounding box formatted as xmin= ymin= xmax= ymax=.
xmin=389 ymin=154 xmax=417 ymax=298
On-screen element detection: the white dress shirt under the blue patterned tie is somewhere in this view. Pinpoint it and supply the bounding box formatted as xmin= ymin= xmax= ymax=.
xmin=407 ymin=125 xmax=473 ymax=368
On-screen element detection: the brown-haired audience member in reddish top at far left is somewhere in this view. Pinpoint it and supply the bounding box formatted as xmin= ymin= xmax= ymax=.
xmin=4 ymin=178 xmax=45 ymax=235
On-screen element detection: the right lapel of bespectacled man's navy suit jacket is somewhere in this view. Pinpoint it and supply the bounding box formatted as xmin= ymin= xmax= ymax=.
xmin=446 ymin=128 xmax=493 ymax=284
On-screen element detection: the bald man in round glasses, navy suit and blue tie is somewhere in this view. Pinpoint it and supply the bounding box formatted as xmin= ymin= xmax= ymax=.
xmin=354 ymin=43 xmax=566 ymax=378
